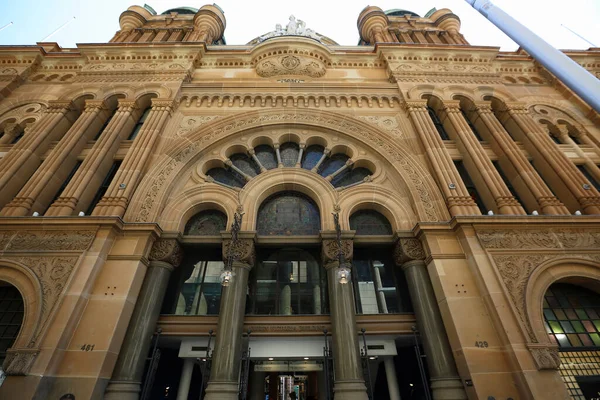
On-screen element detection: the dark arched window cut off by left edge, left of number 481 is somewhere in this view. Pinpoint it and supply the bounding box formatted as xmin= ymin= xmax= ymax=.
xmin=0 ymin=281 xmax=25 ymax=363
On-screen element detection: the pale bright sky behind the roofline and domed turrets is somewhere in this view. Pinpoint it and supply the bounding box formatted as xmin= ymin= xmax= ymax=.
xmin=0 ymin=0 xmax=600 ymax=51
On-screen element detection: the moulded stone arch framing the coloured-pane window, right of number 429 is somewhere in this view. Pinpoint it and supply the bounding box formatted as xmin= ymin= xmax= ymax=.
xmin=524 ymin=257 xmax=600 ymax=343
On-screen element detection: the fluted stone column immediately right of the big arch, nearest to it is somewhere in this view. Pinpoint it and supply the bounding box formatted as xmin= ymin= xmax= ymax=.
xmin=404 ymin=100 xmax=481 ymax=216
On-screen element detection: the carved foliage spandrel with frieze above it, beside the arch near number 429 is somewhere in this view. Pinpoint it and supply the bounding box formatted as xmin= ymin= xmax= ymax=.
xmin=477 ymin=229 xmax=600 ymax=370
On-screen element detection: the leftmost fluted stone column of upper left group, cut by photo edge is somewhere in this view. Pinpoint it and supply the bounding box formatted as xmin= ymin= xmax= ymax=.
xmin=0 ymin=101 xmax=75 ymax=205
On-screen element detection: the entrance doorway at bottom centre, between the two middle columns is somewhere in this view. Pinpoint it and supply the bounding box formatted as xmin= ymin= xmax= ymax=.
xmin=248 ymin=359 xmax=326 ymax=400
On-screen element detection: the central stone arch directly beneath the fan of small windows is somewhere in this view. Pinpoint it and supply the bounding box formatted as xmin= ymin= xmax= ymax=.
xmin=240 ymin=168 xmax=337 ymax=231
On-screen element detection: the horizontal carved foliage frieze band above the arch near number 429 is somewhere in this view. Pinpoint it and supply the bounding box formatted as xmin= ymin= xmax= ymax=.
xmin=477 ymin=229 xmax=600 ymax=249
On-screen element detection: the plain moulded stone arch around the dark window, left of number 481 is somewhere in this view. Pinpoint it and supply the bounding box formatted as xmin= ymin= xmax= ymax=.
xmin=0 ymin=259 xmax=42 ymax=348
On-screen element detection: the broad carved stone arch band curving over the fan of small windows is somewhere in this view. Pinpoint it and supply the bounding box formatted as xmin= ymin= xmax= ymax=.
xmin=125 ymin=109 xmax=449 ymax=222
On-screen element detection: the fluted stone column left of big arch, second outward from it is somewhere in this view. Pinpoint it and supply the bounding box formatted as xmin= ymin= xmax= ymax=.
xmin=45 ymin=100 xmax=140 ymax=216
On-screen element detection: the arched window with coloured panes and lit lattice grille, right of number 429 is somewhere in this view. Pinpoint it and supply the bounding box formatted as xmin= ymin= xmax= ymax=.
xmin=543 ymin=282 xmax=600 ymax=400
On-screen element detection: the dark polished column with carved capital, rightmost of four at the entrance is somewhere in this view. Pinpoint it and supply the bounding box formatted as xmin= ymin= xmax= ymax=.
xmin=394 ymin=239 xmax=467 ymax=400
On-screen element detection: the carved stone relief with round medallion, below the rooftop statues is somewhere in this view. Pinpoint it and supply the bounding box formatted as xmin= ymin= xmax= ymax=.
xmin=256 ymin=54 xmax=326 ymax=78
